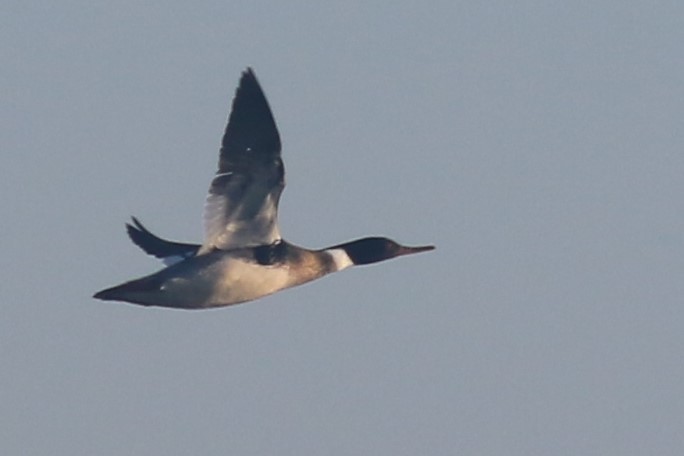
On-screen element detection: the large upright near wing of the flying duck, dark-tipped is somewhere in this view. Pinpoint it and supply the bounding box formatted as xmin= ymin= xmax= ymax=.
xmin=199 ymin=68 xmax=285 ymax=254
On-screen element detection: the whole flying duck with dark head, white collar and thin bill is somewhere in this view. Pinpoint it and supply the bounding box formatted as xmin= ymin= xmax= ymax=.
xmin=93 ymin=67 xmax=435 ymax=309
